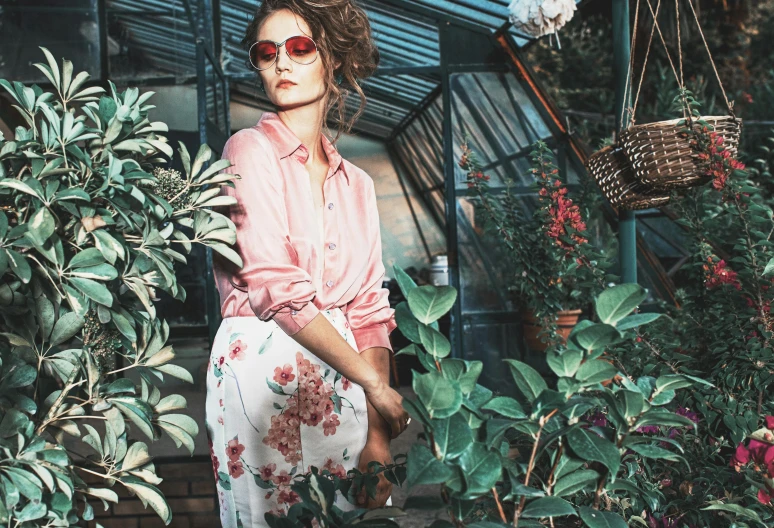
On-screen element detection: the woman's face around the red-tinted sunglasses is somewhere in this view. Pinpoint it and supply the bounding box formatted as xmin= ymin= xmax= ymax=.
xmin=257 ymin=9 xmax=325 ymax=109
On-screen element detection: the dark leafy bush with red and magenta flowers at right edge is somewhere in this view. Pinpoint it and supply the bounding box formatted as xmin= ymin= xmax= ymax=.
xmin=611 ymin=115 xmax=774 ymax=526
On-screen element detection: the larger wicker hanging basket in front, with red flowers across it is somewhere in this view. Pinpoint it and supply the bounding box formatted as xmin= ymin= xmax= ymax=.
xmin=621 ymin=116 xmax=742 ymax=191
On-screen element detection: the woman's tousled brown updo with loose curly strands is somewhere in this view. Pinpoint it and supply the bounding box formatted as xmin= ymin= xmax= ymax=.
xmin=242 ymin=0 xmax=379 ymax=143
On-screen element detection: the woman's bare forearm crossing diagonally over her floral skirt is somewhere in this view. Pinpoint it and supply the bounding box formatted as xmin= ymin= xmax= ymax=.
xmin=293 ymin=313 xmax=389 ymax=392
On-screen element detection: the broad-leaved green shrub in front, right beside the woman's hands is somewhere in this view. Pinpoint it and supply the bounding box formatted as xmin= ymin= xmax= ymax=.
xmin=395 ymin=268 xmax=694 ymax=527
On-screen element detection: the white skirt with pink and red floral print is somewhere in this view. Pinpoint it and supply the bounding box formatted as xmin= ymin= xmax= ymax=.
xmin=205 ymin=308 xmax=391 ymax=528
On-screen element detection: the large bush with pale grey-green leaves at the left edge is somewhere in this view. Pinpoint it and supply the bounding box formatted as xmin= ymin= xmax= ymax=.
xmin=0 ymin=48 xmax=241 ymax=527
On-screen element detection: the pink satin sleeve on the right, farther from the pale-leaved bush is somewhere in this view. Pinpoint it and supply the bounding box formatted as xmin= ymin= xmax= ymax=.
xmin=346 ymin=181 xmax=397 ymax=352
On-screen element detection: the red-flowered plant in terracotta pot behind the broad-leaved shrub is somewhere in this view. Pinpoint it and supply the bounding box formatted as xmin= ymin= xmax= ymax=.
xmin=459 ymin=138 xmax=607 ymax=351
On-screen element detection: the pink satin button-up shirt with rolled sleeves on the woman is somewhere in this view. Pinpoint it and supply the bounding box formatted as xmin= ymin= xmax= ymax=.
xmin=213 ymin=112 xmax=397 ymax=352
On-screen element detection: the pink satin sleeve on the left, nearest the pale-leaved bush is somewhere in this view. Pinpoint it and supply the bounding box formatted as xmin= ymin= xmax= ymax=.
xmin=223 ymin=129 xmax=319 ymax=335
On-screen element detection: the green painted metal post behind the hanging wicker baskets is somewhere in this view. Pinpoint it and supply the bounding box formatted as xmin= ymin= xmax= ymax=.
xmin=613 ymin=0 xmax=637 ymax=282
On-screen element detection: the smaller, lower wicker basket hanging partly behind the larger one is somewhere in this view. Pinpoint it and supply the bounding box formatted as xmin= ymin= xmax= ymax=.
xmin=586 ymin=145 xmax=669 ymax=210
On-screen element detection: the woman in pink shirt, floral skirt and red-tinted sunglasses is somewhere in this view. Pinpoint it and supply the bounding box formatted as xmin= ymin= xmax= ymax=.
xmin=206 ymin=0 xmax=409 ymax=528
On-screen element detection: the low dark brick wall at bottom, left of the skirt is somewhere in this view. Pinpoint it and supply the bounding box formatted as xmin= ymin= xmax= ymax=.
xmin=79 ymin=456 xmax=220 ymax=528
